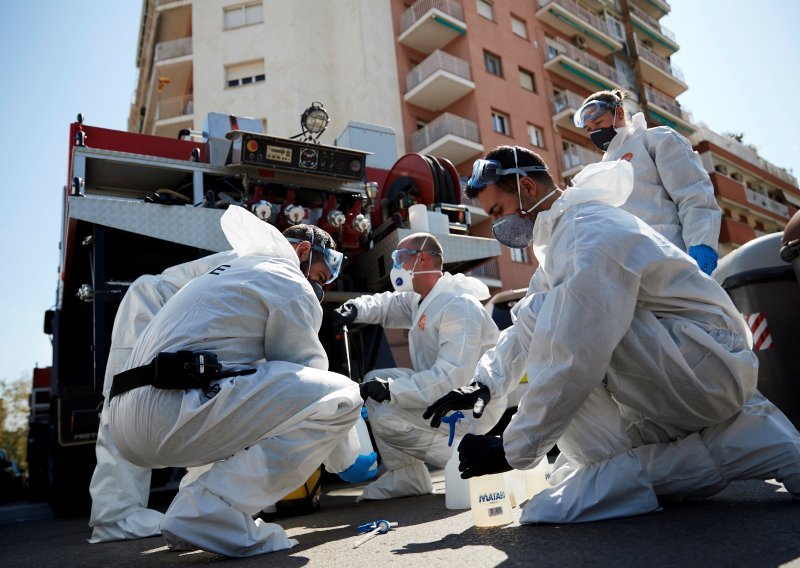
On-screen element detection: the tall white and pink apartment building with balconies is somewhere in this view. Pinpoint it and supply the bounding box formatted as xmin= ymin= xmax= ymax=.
xmin=129 ymin=0 xmax=800 ymax=290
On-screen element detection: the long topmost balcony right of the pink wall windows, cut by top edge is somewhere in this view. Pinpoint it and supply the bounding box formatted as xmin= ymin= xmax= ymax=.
xmin=536 ymin=0 xmax=622 ymax=55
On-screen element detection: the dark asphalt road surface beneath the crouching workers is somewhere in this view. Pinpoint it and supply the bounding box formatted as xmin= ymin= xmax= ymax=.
xmin=0 ymin=472 xmax=800 ymax=568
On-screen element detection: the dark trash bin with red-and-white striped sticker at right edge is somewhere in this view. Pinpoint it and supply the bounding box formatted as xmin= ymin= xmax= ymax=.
xmin=713 ymin=233 xmax=800 ymax=428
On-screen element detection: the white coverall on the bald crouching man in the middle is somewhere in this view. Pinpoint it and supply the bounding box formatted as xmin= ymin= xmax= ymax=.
xmin=352 ymin=272 xmax=504 ymax=500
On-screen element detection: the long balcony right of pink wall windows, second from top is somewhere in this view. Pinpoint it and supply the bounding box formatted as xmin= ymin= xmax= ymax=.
xmin=544 ymin=38 xmax=622 ymax=91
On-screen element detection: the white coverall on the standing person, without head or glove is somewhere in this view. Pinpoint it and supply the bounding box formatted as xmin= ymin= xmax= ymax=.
xmin=603 ymin=112 xmax=722 ymax=251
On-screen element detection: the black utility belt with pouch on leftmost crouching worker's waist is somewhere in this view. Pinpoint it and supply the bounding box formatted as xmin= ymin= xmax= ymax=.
xmin=109 ymin=351 xmax=256 ymax=400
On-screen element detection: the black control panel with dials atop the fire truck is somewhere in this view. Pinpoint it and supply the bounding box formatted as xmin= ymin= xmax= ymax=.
xmin=226 ymin=130 xmax=369 ymax=181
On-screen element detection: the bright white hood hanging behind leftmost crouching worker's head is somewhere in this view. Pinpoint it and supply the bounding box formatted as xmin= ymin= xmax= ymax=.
xmin=220 ymin=205 xmax=300 ymax=268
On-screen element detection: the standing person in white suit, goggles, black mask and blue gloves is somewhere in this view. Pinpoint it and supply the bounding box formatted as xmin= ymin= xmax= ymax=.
xmin=574 ymin=90 xmax=722 ymax=274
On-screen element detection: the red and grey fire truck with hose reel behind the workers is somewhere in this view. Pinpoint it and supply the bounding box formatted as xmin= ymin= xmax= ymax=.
xmin=34 ymin=103 xmax=500 ymax=516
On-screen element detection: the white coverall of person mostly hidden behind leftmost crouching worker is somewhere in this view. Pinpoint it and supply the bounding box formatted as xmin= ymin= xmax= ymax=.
xmin=89 ymin=251 xmax=237 ymax=543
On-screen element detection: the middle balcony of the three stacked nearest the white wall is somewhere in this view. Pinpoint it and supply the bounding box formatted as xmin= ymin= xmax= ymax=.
xmin=403 ymin=49 xmax=475 ymax=110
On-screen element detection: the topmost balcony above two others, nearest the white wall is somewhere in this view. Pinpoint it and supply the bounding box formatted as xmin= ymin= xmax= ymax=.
xmin=397 ymin=0 xmax=467 ymax=53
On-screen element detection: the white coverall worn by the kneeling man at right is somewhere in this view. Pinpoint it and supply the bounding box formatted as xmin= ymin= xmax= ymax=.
xmin=475 ymin=161 xmax=800 ymax=523
